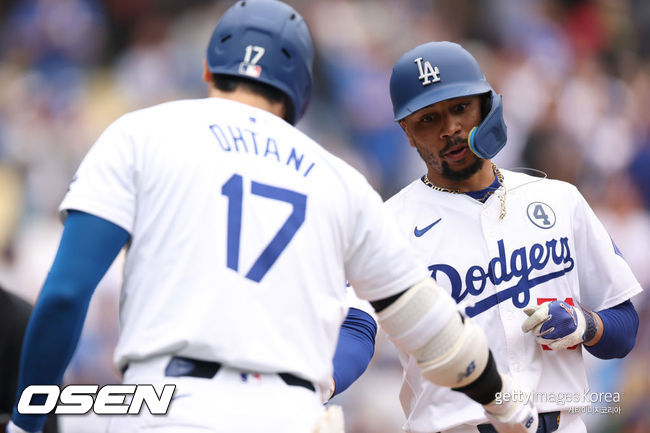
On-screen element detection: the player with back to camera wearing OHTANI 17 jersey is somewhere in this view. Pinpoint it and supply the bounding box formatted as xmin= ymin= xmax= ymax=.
xmin=8 ymin=0 xmax=537 ymax=433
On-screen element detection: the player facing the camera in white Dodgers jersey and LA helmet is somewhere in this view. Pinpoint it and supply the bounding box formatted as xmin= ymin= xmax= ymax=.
xmin=372 ymin=42 xmax=641 ymax=433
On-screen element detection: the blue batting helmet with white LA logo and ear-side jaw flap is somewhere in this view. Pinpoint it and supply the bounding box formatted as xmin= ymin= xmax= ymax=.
xmin=390 ymin=42 xmax=506 ymax=159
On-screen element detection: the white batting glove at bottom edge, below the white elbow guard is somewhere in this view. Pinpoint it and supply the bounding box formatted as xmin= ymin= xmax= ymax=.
xmin=483 ymin=374 xmax=539 ymax=433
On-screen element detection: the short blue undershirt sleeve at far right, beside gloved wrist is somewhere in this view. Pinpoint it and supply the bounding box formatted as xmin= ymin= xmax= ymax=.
xmin=584 ymin=299 xmax=639 ymax=359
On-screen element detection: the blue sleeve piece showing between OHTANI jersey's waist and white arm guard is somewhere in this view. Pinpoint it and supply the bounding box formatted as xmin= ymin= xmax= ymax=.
xmin=333 ymin=308 xmax=377 ymax=395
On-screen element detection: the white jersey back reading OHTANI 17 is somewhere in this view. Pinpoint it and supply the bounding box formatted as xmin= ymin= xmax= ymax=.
xmin=60 ymin=98 xmax=427 ymax=386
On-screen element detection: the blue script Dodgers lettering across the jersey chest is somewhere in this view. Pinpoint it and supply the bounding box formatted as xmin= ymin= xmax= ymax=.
xmin=429 ymin=237 xmax=574 ymax=317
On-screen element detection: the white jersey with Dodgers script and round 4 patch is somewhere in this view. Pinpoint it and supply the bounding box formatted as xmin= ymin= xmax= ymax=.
xmin=386 ymin=170 xmax=641 ymax=432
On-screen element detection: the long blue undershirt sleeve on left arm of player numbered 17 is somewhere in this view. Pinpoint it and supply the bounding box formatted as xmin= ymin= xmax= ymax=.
xmin=12 ymin=211 xmax=130 ymax=431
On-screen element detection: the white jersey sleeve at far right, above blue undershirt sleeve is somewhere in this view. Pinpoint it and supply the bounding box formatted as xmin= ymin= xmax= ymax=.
xmin=570 ymin=186 xmax=642 ymax=311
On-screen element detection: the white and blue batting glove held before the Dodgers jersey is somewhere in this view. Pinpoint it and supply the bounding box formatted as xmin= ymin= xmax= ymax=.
xmin=521 ymin=301 xmax=598 ymax=350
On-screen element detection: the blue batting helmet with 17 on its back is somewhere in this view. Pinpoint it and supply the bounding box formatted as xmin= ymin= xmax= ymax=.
xmin=207 ymin=0 xmax=314 ymax=125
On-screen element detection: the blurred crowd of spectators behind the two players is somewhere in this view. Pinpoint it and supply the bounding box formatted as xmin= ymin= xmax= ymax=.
xmin=0 ymin=0 xmax=650 ymax=433
